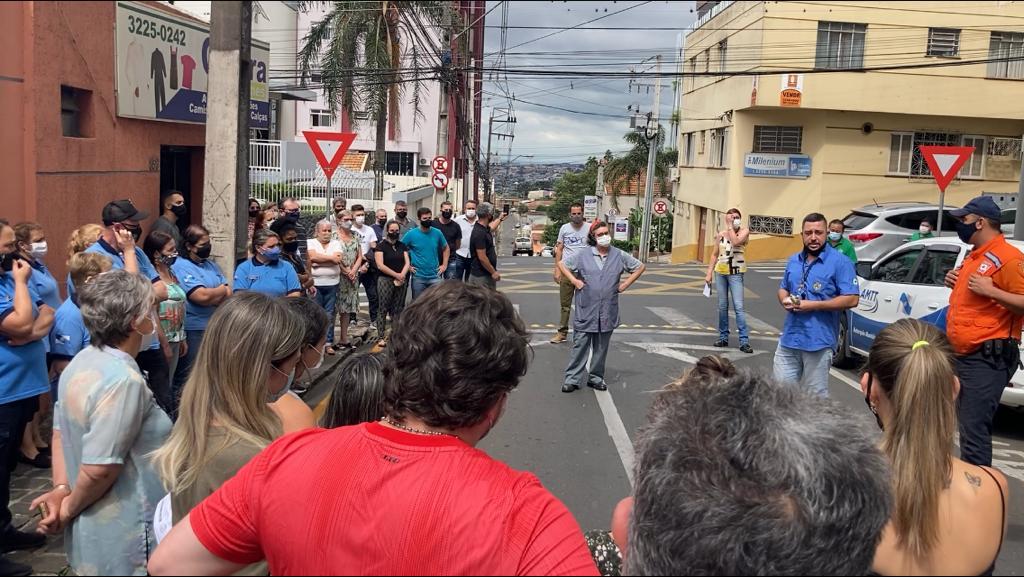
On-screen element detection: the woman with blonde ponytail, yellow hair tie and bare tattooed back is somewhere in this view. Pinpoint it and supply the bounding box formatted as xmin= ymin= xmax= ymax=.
xmin=861 ymin=319 xmax=1007 ymax=575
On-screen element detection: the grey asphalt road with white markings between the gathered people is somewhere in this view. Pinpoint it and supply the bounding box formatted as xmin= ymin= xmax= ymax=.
xmin=481 ymin=220 xmax=1024 ymax=575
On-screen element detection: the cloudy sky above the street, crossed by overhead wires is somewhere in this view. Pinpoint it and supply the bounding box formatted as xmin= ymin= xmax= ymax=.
xmin=481 ymin=0 xmax=695 ymax=163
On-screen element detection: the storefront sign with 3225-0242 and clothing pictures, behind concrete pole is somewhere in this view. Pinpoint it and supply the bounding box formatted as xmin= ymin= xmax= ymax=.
xmin=116 ymin=2 xmax=270 ymax=128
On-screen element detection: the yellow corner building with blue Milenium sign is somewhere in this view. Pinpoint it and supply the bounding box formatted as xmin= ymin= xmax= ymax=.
xmin=672 ymin=1 xmax=1024 ymax=262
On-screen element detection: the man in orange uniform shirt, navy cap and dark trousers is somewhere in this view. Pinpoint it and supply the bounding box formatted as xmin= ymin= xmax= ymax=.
xmin=946 ymin=197 xmax=1024 ymax=466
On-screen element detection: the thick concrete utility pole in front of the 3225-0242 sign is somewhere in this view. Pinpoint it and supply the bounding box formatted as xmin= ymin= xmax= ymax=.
xmin=203 ymin=0 xmax=253 ymax=280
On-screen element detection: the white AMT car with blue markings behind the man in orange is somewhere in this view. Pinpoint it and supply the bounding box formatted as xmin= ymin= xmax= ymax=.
xmin=837 ymin=237 xmax=1024 ymax=408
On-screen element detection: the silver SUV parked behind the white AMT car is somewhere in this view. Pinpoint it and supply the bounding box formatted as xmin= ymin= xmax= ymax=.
xmin=843 ymin=202 xmax=957 ymax=262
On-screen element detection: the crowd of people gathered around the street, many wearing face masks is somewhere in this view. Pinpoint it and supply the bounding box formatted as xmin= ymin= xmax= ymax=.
xmin=0 ymin=193 xmax=1019 ymax=575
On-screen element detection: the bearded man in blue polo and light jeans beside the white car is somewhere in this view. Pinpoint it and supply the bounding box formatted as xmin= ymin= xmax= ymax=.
xmin=775 ymin=213 xmax=860 ymax=397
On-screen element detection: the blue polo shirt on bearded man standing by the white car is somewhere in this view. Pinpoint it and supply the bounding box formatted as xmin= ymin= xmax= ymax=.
xmin=779 ymin=246 xmax=860 ymax=353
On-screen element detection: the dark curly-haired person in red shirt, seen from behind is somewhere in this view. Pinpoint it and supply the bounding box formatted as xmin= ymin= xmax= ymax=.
xmin=150 ymin=283 xmax=598 ymax=575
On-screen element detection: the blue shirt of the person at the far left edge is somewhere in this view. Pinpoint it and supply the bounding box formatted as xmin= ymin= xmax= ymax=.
xmin=0 ymin=273 xmax=50 ymax=405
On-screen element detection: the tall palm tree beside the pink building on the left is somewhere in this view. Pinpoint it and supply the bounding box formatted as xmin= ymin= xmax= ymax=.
xmin=298 ymin=0 xmax=454 ymax=197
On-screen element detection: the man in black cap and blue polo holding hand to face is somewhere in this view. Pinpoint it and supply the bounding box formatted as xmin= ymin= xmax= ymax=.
xmin=85 ymin=200 xmax=173 ymax=414
